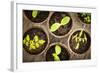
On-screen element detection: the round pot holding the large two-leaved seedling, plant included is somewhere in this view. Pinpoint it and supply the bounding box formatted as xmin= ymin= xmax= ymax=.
xmin=49 ymin=12 xmax=72 ymax=37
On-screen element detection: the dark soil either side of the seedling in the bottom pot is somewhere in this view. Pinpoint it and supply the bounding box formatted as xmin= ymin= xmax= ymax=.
xmin=46 ymin=45 xmax=70 ymax=61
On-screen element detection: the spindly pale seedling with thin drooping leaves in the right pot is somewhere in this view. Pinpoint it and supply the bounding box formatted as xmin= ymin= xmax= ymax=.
xmin=72 ymin=30 xmax=87 ymax=49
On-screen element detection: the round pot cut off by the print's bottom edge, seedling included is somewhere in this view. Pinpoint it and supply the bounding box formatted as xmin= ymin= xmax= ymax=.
xmin=46 ymin=43 xmax=70 ymax=61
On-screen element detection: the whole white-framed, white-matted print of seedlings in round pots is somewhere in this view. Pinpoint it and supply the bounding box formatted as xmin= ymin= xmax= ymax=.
xmin=11 ymin=2 xmax=96 ymax=71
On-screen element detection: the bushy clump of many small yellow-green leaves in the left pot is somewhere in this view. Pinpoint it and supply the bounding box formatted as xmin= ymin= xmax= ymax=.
xmin=23 ymin=35 xmax=45 ymax=50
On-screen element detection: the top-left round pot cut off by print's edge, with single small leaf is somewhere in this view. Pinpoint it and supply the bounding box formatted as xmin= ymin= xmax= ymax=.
xmin=24 ymin=10 xmax=49 ymax=23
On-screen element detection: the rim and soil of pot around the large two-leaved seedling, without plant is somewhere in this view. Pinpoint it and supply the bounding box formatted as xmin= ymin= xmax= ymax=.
xmin=48 ymin=12 xmax=72 ymax=38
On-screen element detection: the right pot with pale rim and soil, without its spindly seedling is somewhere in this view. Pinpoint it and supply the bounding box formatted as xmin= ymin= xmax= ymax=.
xmin=68 ymin=29 xmax=91 ymax=54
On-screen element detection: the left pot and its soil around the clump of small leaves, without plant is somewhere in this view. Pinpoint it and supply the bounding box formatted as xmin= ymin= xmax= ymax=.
xmin=23 ymin=26 xmax=49 ymax=55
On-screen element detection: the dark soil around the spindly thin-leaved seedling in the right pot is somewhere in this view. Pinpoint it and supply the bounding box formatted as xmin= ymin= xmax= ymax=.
xmin=69 ymin=30 xmax=91 ymax=54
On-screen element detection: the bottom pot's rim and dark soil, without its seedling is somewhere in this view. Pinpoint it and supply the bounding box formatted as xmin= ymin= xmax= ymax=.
xmin=45 ymin=43 xmax=70 ymax=61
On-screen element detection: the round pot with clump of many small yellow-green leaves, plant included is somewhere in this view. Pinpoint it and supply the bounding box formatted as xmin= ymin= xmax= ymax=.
xmin=23 ymin=27 xmax=49 ymax=55
